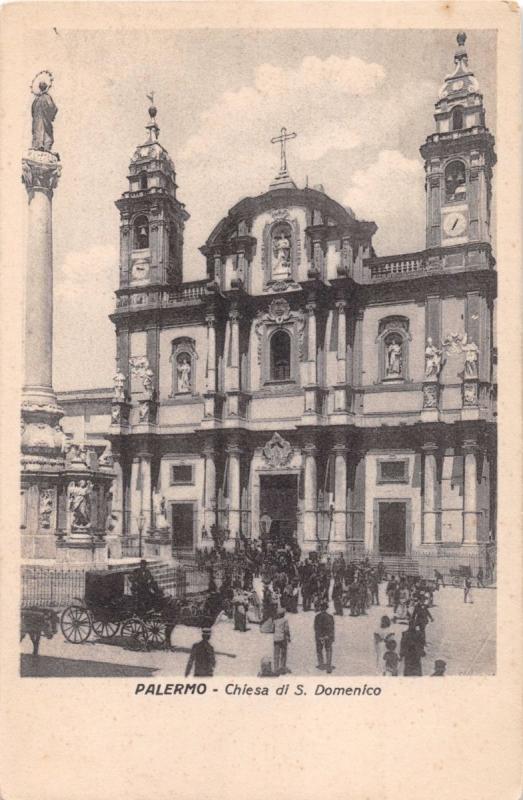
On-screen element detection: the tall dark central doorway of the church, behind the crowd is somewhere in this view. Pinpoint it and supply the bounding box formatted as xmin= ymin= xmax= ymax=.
xmin=260 ymin=474 xmax=298 ymax=544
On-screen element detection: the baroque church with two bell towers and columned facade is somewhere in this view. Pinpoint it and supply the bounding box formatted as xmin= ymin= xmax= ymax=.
xmin=59 ymin=34 xmax=496 ymax=566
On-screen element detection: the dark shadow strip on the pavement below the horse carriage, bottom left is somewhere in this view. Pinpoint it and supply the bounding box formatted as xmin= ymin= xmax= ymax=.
xmin=20 ymin=653 xmax=157 ymax=678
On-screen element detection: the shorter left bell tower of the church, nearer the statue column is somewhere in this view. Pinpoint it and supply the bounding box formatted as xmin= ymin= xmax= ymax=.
xmin=116 ymin=94 xmax=189 ymax=290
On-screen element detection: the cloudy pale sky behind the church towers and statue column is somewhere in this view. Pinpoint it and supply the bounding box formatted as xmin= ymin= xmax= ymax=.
xmin=14 ymin=29 xmax=496 ymax=390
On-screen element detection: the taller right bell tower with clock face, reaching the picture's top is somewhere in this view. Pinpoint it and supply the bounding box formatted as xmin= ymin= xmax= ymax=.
xmin=420 ymin=33 xmax=496 ymax=247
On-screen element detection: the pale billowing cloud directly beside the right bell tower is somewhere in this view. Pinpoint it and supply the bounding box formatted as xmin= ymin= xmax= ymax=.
xmin=344 ymin=150 xmax=425 ymax=255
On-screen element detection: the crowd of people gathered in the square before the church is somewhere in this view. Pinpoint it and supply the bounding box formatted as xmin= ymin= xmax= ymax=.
xmin=180 ymin=540 xmax=458 ymax=676
